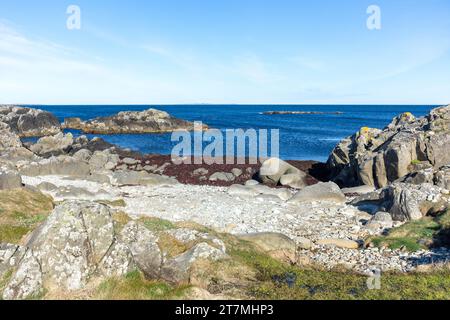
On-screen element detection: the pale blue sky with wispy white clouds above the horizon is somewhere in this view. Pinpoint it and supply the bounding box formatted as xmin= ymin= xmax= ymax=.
xmin=0 ymin=0 xmax=450 ymax=104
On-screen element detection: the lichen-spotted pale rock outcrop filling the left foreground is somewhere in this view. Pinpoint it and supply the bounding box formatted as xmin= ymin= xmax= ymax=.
xmin=0 ymin=201 xmax=227 ymax=300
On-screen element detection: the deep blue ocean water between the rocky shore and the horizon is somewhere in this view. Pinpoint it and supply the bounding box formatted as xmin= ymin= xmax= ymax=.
xmin=26 ymin=105 xmax=436 ymax=161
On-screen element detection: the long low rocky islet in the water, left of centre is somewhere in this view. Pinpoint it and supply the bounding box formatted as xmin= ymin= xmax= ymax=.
xmin=63 ymin=109 xmax=206 ymax=134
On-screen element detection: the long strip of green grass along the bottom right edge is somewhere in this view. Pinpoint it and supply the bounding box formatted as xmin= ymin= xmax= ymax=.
xmin=225 ymin=244 xmax=450 ymax=300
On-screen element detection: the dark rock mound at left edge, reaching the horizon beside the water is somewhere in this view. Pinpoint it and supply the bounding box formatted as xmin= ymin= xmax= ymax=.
xmin=0 ymin=106 xmax=61 ymax=137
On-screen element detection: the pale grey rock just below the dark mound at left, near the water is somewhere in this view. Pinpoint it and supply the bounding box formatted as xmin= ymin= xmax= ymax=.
xmin=30 ymin=132 xmax=73 ymax=156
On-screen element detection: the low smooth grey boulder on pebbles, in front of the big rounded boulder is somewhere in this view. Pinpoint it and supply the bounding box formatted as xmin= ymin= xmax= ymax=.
xmin=289 ymin=182 xmax=346 ymax=203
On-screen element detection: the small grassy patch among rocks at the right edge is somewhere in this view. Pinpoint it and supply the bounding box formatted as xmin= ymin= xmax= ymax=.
xmin=368 ymin=210 xmax=450 ymax=251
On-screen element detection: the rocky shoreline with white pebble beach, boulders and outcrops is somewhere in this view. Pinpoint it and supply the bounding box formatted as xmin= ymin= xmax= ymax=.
xmin=0 ymin=106 xmax=450 ymax=299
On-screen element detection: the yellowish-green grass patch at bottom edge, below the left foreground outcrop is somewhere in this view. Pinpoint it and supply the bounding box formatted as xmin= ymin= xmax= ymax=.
xmin=94 ymin=271 xmax=191 ymax=300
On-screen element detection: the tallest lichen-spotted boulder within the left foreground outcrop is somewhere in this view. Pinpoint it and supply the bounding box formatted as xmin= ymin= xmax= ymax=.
xmin=3 ymin=201 xmax=114 ymax=299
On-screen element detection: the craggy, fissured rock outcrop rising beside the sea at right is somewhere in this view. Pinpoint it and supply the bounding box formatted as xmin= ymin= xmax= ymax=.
xmin=328 ymin=106 xmax=450 ymax=187
